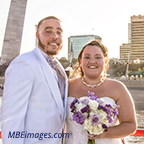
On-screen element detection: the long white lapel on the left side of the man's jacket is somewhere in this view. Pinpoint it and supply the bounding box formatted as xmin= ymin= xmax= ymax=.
xmin=34 ymin=47 xmax=64 ymax=115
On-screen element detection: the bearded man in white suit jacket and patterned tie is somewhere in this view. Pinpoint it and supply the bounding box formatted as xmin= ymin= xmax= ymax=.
xmin=1 ymin=16 xmax=67 ymax=144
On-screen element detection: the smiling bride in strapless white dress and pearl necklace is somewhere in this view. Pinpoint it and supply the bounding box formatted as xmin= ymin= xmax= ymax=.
xmin=66 ymin=40 xmax=137 ymax=144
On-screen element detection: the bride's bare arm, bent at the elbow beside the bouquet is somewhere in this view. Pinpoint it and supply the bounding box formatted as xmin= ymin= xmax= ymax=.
xmin=89 ymin=82 xmax=137 ymax=139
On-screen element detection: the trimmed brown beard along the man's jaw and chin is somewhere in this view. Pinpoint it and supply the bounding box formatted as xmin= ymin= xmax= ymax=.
xmin=38 ymin=38 xmax=62 ymax=56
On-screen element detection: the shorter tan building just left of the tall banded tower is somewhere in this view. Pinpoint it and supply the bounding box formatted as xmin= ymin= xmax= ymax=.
xmin=120 ymin=43 xmax=131 ymax=62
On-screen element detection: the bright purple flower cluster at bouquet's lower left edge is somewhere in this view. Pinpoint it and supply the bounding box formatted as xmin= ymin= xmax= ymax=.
xmin=73 ymin=112 xmax=85 ymax=125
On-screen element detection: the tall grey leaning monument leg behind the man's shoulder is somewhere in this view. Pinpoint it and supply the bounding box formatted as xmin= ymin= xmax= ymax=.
xmin=1 ymin=0 xmax=27 ymax=64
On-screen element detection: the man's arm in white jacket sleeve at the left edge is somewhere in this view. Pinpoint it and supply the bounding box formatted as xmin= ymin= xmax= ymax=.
xmin=1 ymin=61 xmax=34 ymax=144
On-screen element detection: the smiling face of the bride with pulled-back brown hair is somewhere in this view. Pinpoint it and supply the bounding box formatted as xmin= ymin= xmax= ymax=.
xmin=80 ymin=45 xmax=105 ymax=77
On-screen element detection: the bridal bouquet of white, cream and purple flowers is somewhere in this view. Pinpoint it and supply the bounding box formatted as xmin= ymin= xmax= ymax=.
xmin=70 ymin=92 xmax=118 ymax=144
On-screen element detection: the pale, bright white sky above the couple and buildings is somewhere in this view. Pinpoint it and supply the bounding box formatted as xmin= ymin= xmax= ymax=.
xmin=0 ymin=0 xmax=144 ymax=58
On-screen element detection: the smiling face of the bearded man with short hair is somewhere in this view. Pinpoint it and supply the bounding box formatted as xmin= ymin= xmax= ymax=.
xmin=36 ymin=19 xmax=63 ymax=57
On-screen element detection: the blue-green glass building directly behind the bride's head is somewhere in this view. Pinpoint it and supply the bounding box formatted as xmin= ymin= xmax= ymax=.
xmin=68 ymin=35 xmax=102 ymax=61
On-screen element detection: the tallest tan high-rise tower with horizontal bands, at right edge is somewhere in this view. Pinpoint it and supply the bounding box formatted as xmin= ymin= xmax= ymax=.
xmin=130 ymin=15 xmax=144 ymax=62
